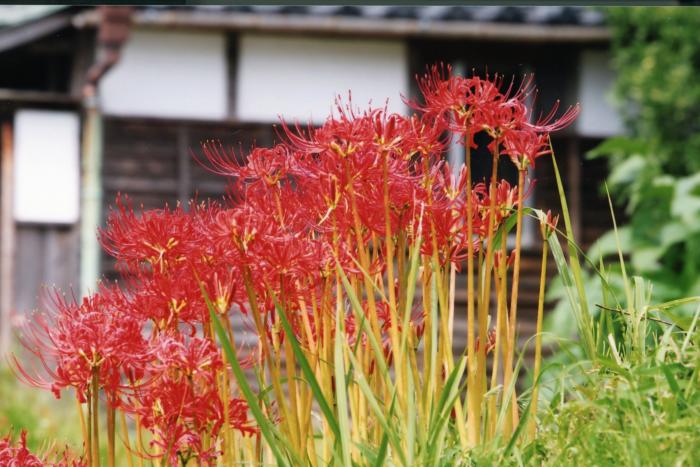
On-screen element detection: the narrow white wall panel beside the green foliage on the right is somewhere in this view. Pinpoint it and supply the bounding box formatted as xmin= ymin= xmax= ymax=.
xmin=576 ymin=50 xmax=624 ymax=138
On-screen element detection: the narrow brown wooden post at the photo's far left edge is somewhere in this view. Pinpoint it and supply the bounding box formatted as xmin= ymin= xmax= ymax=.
xmin=0 ymin=122 xmax=15 ymax=354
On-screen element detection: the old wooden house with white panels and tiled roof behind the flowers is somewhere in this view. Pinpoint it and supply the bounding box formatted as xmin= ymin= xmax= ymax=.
xmin=0 ymin=6 xmax=622 ymax=352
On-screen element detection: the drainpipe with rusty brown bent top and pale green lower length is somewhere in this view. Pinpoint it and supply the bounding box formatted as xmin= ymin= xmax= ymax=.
xmin=80 ymin=6 xmax=132 ymax=296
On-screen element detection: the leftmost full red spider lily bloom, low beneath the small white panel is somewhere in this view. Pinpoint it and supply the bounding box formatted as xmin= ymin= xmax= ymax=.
xmin=14 ymin=286 xmax=148 ymax=404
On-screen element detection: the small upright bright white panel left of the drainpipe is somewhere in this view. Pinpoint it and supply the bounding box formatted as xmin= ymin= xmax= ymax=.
xmin=14 ymin=110 xmax=80 ymax=224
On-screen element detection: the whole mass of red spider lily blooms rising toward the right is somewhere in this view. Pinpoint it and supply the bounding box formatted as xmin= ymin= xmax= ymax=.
xmin=10 ymin=67 xmax=577 ymax=465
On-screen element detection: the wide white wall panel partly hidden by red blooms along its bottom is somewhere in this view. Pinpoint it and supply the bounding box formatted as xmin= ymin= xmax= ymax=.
xmin=236 ymin=34 xmax=409 ymax=123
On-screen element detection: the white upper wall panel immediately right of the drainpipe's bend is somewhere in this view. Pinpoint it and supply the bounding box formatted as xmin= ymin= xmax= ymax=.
xmin=100 ymin=29 xmax=228 ymax=120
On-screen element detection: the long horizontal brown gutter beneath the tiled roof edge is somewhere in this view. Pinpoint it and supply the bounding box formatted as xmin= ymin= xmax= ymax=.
xmin=73 ymin=10 xmax=610 ymax=43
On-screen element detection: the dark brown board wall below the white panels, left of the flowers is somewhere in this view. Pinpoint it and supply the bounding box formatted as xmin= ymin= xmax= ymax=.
xmin=101 ymin=117 xmax=273 ymax=278
